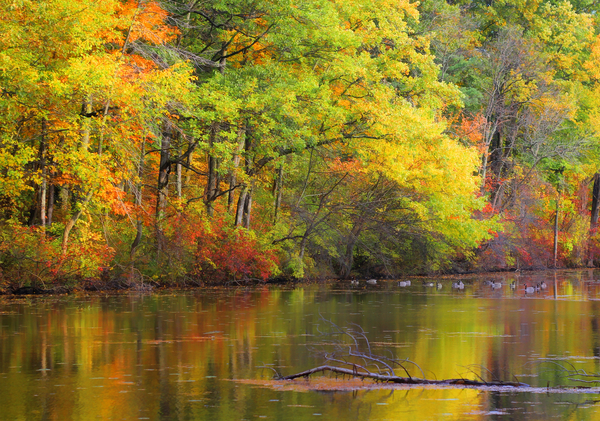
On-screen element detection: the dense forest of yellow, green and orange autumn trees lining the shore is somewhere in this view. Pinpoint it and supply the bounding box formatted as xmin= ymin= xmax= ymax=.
xmin=0 ymin=0 xmax=600 ymax=289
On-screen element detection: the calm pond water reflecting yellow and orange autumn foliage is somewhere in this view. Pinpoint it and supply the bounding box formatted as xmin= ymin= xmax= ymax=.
xmin=0 ymin=271 xmax=600 ymax=421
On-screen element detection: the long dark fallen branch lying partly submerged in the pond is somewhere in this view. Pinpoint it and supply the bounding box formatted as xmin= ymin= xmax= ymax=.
xmin=278 ymin=365 xmax=529 ymax=387
